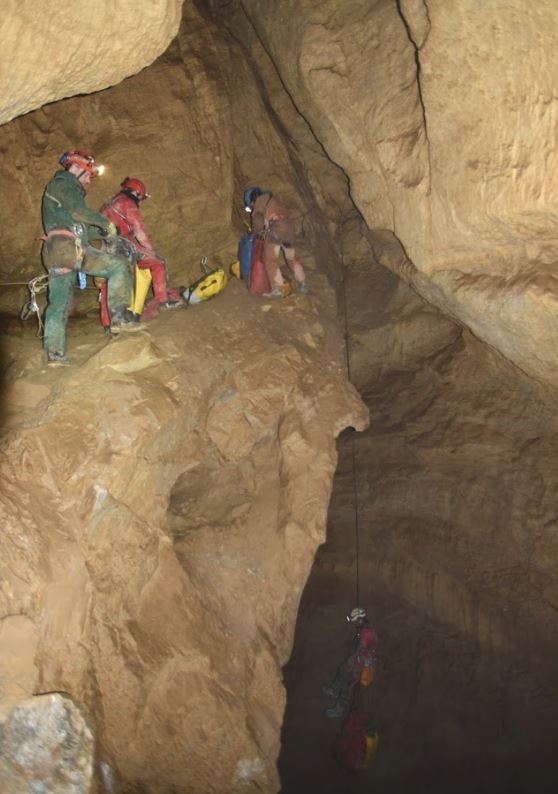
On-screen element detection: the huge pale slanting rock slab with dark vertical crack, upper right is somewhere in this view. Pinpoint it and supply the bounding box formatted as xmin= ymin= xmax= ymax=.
xmin=242 ymin=0 xmax=558 ymax=383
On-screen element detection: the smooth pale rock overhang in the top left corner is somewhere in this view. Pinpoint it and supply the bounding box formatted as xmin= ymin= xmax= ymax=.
xmin=0 ymin=0 xmax=182 ymax=124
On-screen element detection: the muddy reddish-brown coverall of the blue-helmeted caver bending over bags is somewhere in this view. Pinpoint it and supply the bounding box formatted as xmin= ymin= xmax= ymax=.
xmin=252 ymin=193 xmax=305 ymax=289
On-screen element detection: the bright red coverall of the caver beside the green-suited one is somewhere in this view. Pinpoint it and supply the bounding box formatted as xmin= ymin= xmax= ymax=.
xmin=101 ymin=192 xmax=168 ymax=326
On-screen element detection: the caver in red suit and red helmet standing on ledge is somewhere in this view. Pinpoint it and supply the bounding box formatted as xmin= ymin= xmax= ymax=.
xmin=101 ymin=176 xmax=183 ymax=324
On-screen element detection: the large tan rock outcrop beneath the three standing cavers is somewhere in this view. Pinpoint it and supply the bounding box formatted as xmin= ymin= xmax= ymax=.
xmin=0 ymin=282 xmax=367 ymax=794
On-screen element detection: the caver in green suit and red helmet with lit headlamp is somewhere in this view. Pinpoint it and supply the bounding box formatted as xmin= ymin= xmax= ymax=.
xmin=42 ymin=151 xmax=135 ymax=366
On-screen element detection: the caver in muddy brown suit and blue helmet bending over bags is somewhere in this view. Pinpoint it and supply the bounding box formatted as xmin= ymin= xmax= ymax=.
xmin=244 ymin=187 xmax=308 ymax=298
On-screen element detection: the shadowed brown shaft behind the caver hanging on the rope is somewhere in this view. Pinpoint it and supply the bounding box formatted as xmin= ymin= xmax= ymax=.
xmin=279 ymin=255 xmax=558 ymax=794
